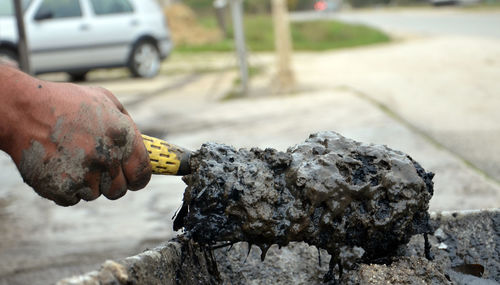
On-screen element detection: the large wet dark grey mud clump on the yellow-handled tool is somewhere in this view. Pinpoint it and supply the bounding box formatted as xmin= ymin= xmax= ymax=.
xmin=174 ymin=132 xmax=433 ymax=279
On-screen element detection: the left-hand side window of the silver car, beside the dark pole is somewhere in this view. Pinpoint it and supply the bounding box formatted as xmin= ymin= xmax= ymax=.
xmin=35 ymin=0 xmax=82 ymax=19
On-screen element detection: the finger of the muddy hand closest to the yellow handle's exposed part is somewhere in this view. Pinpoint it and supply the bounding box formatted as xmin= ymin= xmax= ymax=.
xmin=122 ymin=129 xmax=151 ymax=190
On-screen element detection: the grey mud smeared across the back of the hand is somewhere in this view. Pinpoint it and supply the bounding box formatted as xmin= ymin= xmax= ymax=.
xmin=19 ymin=100 xmax=135 ymax=206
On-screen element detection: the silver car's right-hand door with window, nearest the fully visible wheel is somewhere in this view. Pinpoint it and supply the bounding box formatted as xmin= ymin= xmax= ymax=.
xmin=84 ymin=0 xmax=139 ymax=65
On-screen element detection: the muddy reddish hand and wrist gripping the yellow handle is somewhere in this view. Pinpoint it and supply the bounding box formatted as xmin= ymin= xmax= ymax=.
xmin=0 ymin=66 xmax=151 ymax=206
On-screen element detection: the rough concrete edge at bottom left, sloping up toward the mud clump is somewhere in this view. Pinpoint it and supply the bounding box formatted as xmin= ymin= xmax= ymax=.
xmin=57 ymin=239 xmax=219 ymax=285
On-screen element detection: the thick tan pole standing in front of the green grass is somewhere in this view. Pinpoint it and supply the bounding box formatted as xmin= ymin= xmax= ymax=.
xmin=272 ymin=0 xmax=295 ymax=93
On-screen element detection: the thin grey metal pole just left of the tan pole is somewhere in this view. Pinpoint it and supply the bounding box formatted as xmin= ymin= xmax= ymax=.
xmin=231 ymin=0 xmax=248 ymax=94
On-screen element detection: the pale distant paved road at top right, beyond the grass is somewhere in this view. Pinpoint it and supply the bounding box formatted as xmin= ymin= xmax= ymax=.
xmin=291 ymin=8 xmax=500 ymax=38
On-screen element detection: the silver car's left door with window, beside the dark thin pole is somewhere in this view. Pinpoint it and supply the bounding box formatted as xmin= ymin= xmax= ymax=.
xmin=27 ymin=0 xmax=95 ymax=72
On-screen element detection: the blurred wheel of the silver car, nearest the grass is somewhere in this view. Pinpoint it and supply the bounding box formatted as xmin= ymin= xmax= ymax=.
xmin=129 ymin=41 xmax=161 ymax=78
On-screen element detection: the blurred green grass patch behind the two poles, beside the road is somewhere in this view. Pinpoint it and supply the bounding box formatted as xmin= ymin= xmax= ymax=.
xmin=176 ymin=15 xmax=390 ymax=52
